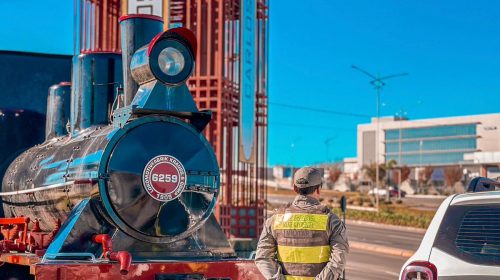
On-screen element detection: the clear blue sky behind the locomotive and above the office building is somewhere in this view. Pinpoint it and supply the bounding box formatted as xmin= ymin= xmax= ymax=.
xmin=0 ymin=0 xmax=500 ymax=165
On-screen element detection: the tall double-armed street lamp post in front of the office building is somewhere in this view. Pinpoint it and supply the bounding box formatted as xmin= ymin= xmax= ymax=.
xmin=351 ymin=65 xmax=408 ymax=210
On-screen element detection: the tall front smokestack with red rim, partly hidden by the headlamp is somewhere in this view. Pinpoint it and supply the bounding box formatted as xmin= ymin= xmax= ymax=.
xmin=119 ymin=14 xmax=163 ymax=106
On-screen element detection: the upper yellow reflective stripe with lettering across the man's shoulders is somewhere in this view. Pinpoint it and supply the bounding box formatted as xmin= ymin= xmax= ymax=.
xmin=273 ymin=213 xmax=328 ymax=230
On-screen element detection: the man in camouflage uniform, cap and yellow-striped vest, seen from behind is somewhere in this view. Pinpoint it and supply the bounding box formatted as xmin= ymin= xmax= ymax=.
xmin=255 ymin=167 xmax=349 ymax=280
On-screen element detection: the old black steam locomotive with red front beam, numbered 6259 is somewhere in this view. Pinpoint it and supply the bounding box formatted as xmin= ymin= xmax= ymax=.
xmin=0 ymin=15 xmax=262 ymax=280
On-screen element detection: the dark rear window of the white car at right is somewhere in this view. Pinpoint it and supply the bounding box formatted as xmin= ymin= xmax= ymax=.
xmin=434 ymin=205 xmax=500 ymax=265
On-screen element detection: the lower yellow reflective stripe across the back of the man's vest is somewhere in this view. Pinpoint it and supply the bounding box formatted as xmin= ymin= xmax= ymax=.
xmin=278 ymin=245 xmax=330 ymax=263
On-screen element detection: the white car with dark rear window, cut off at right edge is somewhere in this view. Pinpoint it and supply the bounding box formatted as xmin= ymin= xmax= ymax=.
xmin=399 ymin=178 xmax=500 ymax=280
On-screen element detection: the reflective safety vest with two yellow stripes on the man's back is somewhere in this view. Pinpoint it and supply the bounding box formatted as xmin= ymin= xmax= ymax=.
xmin=272 ymin=206 xmax=331 ymax=280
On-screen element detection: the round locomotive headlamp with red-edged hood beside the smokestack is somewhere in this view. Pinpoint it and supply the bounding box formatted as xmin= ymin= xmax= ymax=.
xmin=130 ymin=28 xmax=196 ymax=86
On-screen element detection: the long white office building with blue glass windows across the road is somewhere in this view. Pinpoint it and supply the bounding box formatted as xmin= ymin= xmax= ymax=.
xmin=357 ymin=114 xmax=500 ymax=176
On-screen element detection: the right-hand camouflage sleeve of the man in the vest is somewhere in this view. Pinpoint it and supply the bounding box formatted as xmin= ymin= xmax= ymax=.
xmin=316 ymin=213 xmax=349 ymax=280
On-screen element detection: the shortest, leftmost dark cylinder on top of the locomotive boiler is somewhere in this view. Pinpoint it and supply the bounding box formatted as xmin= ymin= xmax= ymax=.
xmin=45 ymin=82 xmax=71 ymax=140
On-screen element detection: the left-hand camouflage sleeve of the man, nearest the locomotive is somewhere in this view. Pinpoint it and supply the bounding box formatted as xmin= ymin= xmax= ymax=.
xmin=255 ymin=217 xmax=284 ymax=280
